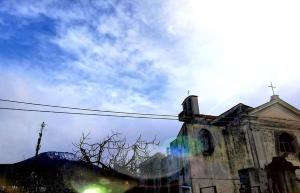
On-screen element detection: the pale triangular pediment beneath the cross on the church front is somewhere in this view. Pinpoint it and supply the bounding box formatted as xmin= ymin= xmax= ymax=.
xmin=249 ymin=99 xmax=300 ymax=121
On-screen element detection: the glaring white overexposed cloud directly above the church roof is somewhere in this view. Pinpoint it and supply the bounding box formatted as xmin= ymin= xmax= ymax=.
xmin=156 ymin=0 xmax=300 ymax=113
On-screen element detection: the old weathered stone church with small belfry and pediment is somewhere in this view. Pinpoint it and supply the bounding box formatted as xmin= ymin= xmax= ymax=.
xmin=166 ymin=95 xmax=300 ymax=193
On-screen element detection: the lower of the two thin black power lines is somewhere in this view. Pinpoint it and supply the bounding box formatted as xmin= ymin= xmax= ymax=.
xmin=0 ymin=107 xmax=178 ymax=120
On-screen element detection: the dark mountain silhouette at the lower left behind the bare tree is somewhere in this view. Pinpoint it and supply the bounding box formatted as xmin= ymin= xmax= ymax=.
xmin=0 ymin=152 xmax=138 ymax=193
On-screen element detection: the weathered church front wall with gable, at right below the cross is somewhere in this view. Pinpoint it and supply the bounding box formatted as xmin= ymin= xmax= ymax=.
xmin=250 ymin=101 xmax=300 ymax=168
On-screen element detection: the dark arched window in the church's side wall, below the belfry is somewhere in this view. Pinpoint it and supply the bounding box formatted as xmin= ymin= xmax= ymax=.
xmin=199 ymin=129 xmax=214 ymax=155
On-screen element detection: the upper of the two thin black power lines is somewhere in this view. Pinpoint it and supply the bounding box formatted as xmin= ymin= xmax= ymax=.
xmin=0 ymin=99 xmax=177 ymax=118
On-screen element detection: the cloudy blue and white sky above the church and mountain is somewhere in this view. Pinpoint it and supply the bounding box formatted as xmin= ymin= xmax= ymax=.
xmin=0 ymin=0 xmax=300 ymax=163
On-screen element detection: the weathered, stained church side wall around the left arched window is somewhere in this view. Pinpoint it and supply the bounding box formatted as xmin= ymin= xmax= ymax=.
xmin=187 ymin=124 xmax=253 ymax=192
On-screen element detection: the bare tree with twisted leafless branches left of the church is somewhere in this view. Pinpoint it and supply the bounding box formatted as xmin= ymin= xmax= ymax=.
xmin=73 ymin=132 xmax=159 ymax=174
